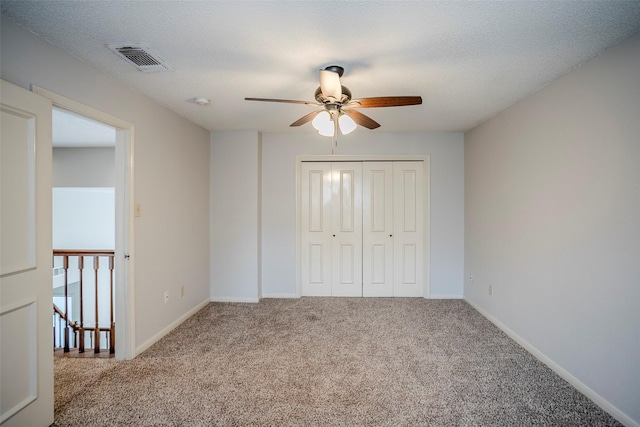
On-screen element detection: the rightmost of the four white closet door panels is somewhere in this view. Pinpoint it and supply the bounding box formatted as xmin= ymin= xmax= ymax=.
xmin=393 ymin=162 xmax=424 ymax=297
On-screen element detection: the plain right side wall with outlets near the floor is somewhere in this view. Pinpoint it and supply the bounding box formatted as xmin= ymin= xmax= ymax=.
xmin=464 ymin=32 xmax=640 ymax=425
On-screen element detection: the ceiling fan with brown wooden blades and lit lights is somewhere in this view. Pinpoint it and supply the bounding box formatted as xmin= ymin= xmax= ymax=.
xmin=245 ymin=65 xmax=422 ymax=143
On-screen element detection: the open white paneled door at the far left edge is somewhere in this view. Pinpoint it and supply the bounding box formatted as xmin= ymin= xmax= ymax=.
xmin=0 ymin=81 xmax=53 ymax=426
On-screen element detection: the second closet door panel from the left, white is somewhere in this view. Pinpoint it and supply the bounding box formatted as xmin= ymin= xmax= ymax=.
xmin=331 ymin=162 xmax=362 ymax=297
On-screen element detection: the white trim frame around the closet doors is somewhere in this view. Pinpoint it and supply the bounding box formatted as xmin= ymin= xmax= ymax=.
xmin=295 ymin=154 xmax=431 ymax=298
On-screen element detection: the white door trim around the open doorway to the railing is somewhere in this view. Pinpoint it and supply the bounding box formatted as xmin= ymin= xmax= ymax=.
xmin=31 ymin=85 xmax=136 ymax=360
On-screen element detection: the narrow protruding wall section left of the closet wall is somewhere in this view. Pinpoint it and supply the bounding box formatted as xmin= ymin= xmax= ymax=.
xmin=210 ymin=131 xmax=261 ymax=302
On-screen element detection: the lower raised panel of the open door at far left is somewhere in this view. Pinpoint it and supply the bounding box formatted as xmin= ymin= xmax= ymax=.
xmin=0 ymin=301 xmax=38 ymax=422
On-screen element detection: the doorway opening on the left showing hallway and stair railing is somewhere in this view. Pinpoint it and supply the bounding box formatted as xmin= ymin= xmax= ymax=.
xmin=52 ymin=108 xmax=121 ymax=357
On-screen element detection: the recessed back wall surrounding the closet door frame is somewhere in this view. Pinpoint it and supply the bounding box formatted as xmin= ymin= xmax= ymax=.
xmin=262 ymin=132 xmax=464 ymax=297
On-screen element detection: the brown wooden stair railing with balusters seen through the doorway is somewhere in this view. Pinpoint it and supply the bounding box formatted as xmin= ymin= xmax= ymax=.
xmin=53 ymin=249 xmax=115 ymax=354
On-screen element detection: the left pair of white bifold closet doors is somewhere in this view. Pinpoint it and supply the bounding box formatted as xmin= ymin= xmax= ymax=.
xmin=300 ymin=162 xmax=362 ymax=296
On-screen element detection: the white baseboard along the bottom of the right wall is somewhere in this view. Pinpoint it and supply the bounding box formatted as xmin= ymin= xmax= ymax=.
xmin=464 ymin=297 xmax=640 ymax=427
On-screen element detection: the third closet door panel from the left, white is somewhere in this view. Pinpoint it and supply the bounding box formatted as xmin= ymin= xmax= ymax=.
xmin=362 ymin=162 xmax=393 ymax=297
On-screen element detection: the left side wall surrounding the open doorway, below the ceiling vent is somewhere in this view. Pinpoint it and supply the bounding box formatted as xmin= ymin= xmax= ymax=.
xmin=0 ymin=18 xmax=213 ymax=348
